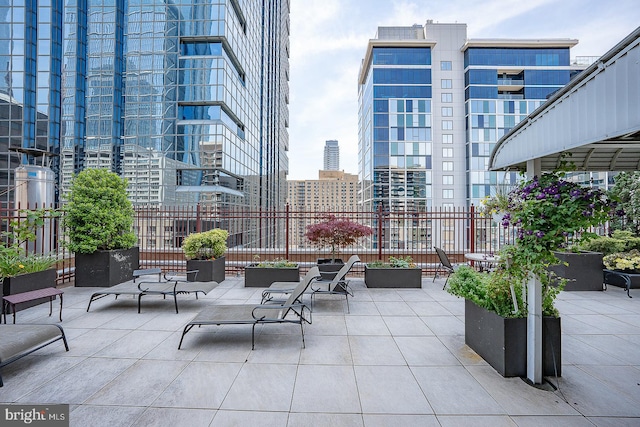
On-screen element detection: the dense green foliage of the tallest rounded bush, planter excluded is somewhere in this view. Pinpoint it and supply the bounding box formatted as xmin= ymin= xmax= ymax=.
xmin=64 ymin=169 xmax=136 ymax=254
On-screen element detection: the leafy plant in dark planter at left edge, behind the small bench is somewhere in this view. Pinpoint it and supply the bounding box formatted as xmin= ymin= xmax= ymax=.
xmin=0 ymin=208 xmax=59 ymax=311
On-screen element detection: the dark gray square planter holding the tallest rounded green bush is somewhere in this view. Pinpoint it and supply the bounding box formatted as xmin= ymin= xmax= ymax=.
xmin=75 ymin=246 xmax=140 ymax=287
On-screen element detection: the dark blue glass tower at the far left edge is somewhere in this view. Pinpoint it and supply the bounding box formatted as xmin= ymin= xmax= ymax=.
xmin=0 ymin=0 xmax=62 ymax=202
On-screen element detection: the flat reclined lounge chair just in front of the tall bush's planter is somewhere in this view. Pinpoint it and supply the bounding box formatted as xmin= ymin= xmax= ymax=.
xmin=87 ymin=270 xmax=218 ymax=313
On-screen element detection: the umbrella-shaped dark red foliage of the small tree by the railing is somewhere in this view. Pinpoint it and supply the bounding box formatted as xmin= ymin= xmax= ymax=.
xmin=305 ymin=215 xmax=373 ymax=262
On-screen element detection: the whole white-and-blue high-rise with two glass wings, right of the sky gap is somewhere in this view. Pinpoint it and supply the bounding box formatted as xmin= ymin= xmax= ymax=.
xmin=358 ymin=21 xmax=584 ymax=251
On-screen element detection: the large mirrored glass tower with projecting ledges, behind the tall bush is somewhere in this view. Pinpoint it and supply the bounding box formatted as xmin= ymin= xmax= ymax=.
xmin=60 ymin=0 xmax=289 ymax=213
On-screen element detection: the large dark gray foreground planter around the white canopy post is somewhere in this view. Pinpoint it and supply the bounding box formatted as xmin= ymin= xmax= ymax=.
xmin=464 ymin=300 xmax=562 ymax=377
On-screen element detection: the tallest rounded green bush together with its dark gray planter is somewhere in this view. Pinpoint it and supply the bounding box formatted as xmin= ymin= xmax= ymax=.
xmin=63 ymin=169 xmax=140 ymax=287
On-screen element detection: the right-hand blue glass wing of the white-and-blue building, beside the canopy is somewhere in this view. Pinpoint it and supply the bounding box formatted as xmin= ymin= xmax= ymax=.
xmin=464 ymin=47 xmax=570 ymax=206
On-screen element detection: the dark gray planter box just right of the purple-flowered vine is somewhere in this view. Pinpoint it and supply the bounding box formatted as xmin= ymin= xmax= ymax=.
xmin=549 ymin=251 xmax=603 ymax=291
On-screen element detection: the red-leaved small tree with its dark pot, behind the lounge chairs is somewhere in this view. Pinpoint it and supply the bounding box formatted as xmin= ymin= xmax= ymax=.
xmin=305 ymin=215 xmax=373 ymax=280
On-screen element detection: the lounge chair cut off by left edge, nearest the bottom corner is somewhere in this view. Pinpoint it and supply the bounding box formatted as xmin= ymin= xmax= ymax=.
xmin=0 ymin=324 xmax=69 ymax=387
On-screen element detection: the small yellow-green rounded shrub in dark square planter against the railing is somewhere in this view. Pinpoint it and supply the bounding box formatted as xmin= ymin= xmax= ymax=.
xmin=182 ymin=228 xmax=229 ymax=283
